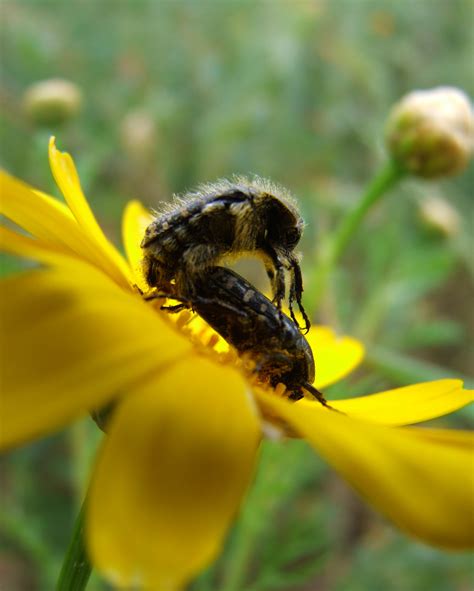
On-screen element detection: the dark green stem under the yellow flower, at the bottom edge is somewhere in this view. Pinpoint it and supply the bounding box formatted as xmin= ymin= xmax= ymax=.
xmin=56 ymin=503 xmax=92 ymax=591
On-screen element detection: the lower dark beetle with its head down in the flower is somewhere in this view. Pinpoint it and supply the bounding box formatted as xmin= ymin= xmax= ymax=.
xmin=154 ymin=266 xmax=330 ymax=408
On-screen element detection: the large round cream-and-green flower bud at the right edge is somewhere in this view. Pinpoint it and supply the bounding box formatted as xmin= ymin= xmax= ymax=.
xmin=386 ymin=86 xmax=474 ymax=178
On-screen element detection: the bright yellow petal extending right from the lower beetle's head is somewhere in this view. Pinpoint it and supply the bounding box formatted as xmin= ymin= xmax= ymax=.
xmin=331 ymin=380 xmax=473 ymax=425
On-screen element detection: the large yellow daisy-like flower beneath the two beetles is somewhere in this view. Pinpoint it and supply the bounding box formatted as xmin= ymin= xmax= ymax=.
xmin=0 ymin=141 xmax=474 ymax=590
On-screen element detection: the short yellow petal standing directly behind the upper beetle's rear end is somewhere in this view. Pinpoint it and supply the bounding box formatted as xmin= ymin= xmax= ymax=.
xmin=122 ymin=201 xmax=153 ymax=291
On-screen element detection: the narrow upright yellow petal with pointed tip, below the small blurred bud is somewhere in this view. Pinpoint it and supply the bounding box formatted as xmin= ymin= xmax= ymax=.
xmin=49 ymin=137 xmax=133 ymax=284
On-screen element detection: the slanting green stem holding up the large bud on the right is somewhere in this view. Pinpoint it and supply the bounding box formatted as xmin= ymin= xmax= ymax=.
xmin=308 ymin=160 xmax=404 ymax=306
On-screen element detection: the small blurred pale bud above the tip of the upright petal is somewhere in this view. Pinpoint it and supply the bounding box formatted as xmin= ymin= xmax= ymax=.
xmin=23 ymin=78 xmax=82 ymax=125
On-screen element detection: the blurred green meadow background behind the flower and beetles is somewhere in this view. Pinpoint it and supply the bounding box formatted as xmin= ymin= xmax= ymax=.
xmin=0 ymin=0 xmax=474 ymax=591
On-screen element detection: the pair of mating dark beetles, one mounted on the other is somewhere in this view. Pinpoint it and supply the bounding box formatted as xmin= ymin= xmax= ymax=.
xmin=142 ymin=178 xmax=326 ymax=405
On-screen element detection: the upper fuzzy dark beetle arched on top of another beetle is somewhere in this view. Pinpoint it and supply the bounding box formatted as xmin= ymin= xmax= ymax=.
xmin=141 ymin=177 xmax=310 ymax=331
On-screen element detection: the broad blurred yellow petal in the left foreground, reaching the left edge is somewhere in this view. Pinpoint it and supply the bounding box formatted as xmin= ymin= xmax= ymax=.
xmin=0 ymin=262 xmax=190 ymax=447
